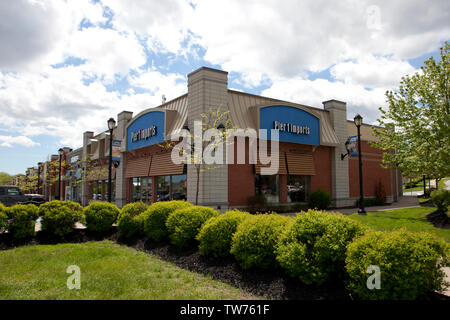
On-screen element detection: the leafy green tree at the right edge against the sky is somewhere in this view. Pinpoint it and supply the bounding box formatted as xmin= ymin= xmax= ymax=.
xmin=373 ymin=42 xmax=450 ymax=186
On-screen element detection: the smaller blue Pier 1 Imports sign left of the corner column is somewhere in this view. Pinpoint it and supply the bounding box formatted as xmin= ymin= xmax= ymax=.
xmin=127 ymin=111 xmax=165 ymax=151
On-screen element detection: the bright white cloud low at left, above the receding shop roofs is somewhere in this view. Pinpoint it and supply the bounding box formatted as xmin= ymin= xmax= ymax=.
xmin=0 ymin=66 xmax=187 ymax=147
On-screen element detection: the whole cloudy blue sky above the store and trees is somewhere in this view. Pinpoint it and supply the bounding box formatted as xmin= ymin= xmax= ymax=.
xmin=0 ymin=0 xmax=450 ymax=174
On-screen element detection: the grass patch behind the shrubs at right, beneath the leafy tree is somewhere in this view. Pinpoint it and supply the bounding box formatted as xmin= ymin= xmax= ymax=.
xmin=349 ymin=207 xmax=450 ymax=242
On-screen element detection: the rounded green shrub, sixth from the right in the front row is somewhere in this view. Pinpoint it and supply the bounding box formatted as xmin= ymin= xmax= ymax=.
xmin=143 ymin=200 xmax=192 ymax=241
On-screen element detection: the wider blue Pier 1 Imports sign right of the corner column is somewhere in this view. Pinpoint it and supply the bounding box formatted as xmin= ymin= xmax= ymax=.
xmin=259 ymin=105 xmax=320 ymax=145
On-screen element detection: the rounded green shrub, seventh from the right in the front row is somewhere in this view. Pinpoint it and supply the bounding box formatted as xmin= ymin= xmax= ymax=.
xmin=117 ymin=201 xmax=149 ymax=238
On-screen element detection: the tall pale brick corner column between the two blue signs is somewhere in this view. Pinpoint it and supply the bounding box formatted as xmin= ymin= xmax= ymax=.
xmin=187 ymin=67 xmax=228 ymax=210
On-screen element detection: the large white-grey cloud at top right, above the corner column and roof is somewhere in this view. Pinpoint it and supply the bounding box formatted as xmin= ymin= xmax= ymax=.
xmin=185 ymin=0 xmax=450 ymax=84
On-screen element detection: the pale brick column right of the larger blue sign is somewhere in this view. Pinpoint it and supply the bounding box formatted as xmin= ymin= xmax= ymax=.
xmin=322 ymin=100 xmax=354 ymax=208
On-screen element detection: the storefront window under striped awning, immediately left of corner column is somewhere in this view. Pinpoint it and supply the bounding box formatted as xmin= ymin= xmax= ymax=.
xmin=156 ymin=174 xmax=186 ymax=201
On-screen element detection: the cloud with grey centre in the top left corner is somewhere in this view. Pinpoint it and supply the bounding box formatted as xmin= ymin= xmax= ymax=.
xmin=0 ymin=0 xmax=106 ymax=72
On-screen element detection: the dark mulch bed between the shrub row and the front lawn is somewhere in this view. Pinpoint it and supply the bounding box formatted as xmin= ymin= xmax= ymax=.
xmin=0 ymin=229 xmax=450 ymax=300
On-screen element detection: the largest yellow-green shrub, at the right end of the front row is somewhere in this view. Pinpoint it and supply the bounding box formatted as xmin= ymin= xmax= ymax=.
xmin=346 ymin=230 xmax=450 ymax=300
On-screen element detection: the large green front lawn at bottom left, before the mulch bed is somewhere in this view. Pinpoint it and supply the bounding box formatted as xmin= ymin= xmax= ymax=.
xmin=0 ymin=241 xmax=258 ymax=300
